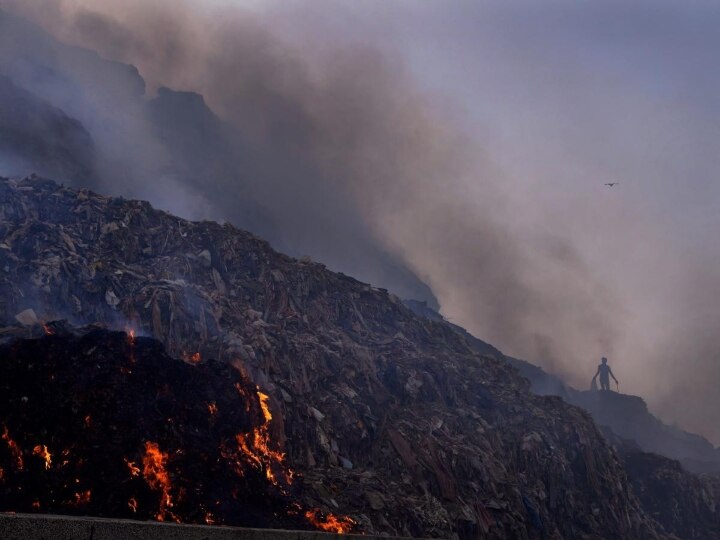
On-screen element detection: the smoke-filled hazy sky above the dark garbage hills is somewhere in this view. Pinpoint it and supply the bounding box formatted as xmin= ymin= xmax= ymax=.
xmin=5 ymin=0 xmax=720 ymax=444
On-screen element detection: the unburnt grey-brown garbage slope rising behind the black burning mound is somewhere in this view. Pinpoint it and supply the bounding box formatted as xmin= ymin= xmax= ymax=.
xmin=0 ymin=178 xmax=664 ymax=538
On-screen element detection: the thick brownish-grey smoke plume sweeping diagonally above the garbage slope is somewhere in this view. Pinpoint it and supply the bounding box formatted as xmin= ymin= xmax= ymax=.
xmin=0 ymin=0 xmax=720 ymax=438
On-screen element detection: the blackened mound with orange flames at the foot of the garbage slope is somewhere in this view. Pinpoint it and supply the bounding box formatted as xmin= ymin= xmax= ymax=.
xmin=0 ymin=329 xmax=354 ymax=532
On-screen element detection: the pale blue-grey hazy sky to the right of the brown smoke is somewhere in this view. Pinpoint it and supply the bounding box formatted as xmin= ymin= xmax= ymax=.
xmin=372 ymin=0 xmax=720 ymax=443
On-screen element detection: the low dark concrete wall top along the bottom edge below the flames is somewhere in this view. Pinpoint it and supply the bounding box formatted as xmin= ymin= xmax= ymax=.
xmin=0 ymin=513 xmax=387 ymax=540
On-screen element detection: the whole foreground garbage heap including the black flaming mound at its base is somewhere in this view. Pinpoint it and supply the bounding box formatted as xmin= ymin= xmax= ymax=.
xmin=0 ymin=177 xmax=716 ymax=539
